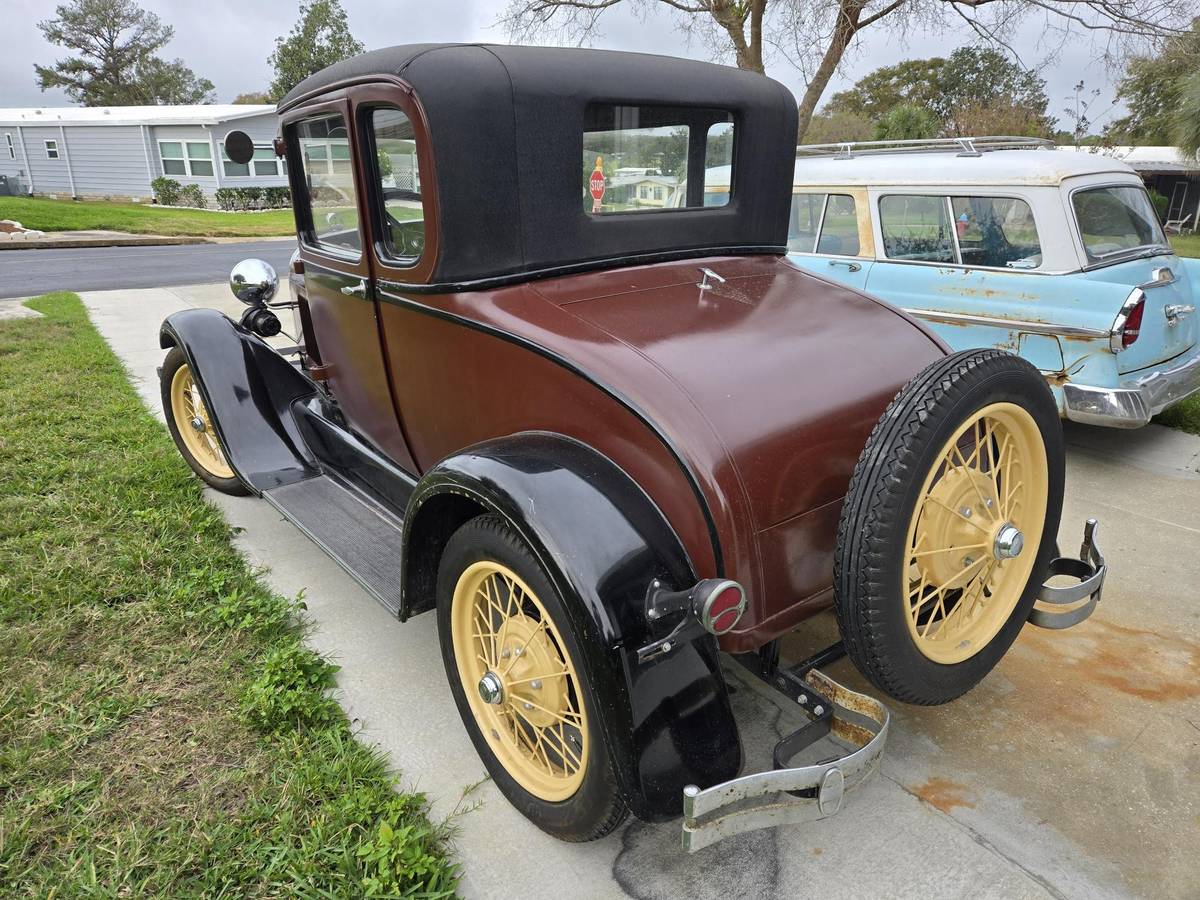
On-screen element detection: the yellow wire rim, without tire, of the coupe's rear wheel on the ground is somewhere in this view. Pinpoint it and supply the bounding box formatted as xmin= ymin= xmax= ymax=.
xmin=450 ymin=560 xmax=589 ymax=802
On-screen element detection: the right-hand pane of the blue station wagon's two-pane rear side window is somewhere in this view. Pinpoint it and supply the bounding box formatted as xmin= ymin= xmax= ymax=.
xmin=950 ymin=197 xmax=1042 ymax=269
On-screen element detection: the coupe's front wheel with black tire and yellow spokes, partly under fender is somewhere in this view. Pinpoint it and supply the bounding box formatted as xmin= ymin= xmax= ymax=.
xmin=158 ymin=347 xmax=250 ymax=497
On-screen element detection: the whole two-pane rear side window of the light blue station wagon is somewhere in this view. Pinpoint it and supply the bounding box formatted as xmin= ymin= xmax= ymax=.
xmin=880 ymin=194 xmax=1042 ymax=269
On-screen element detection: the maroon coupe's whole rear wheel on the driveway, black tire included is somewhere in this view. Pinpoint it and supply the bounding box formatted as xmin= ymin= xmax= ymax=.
xmin=438 ymin=516 xmax=628 ymax=841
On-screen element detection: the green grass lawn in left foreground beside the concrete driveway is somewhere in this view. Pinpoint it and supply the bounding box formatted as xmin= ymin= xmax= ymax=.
xmin=0 ymin=294 xmax=457 ymax=898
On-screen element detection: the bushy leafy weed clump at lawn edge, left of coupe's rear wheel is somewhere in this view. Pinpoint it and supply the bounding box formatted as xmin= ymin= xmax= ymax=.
xmin=242 ymin=640 xmax=341 ymax=731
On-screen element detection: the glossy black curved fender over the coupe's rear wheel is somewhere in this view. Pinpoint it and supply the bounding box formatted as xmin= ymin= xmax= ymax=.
xmin=401 ymin=432 xmax=742 ymax=820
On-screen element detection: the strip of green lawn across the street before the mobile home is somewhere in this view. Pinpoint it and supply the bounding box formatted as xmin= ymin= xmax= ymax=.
xmin=0 ymin=197 xmax=295 ymax=238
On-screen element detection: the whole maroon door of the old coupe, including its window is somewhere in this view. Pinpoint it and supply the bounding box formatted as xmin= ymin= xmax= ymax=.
xmin=283 ymin=100 xmax=413 ymax=469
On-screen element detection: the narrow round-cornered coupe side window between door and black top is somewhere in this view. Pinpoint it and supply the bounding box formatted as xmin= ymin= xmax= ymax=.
xmin=371 ymin=108 xmax=425 ymax=264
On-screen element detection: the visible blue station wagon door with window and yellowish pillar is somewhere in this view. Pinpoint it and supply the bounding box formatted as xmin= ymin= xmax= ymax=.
xmin=787 ymin=187 xmax=875 ymax=289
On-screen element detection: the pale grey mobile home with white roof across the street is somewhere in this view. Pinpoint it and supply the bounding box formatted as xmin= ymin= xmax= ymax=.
xmin=0 ymin=104 xmax=287 ymax=200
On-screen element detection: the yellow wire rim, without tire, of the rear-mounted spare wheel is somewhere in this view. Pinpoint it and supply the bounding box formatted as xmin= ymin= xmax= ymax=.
xmin=901 ymin=403 xmax=1049 ymax=665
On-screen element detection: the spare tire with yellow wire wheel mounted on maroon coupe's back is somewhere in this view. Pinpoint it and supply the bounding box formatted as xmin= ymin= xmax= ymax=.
xmin=834 ymin=349 xmax=1064 ymax=704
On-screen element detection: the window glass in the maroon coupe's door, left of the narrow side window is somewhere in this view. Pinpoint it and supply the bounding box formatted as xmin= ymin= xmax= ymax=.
xmin=295 ymin=115 xmax=362 ymax=256
